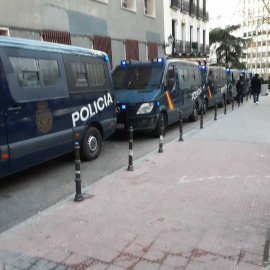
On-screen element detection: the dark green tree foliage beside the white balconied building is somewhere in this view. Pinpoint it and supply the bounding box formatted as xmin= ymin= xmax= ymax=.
xmin=209 ymin=24 xmax=250 ymax=69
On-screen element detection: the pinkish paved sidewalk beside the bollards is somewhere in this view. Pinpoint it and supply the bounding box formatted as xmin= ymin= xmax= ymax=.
xmin=0 ymin=96 xmax=270 ymax=270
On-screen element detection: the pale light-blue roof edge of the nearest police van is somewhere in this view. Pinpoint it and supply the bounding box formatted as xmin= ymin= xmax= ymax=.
xmin=0 ymin=36 xmax=106 ymax=57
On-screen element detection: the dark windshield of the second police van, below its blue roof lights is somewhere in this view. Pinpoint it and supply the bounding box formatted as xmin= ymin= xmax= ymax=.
xmin=113 ymin=65 xmax=163 ymax=90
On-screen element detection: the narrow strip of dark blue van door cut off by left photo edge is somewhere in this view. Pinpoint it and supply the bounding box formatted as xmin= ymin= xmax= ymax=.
xmin=0 ymin=56 xmax=9 ymax=176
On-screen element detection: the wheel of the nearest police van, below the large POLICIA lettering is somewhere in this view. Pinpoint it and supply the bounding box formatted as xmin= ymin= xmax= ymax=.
xmin=81 ymin=127 xmax=102 ymax=161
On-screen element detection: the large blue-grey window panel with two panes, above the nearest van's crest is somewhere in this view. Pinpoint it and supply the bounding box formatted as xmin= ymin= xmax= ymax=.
xmin=1 ymin=48 xmax=68 ymax=102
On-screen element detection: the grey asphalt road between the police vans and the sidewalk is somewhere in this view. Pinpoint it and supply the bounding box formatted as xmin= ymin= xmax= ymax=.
xmin=0 ymin=105 xmax=231 ymax=233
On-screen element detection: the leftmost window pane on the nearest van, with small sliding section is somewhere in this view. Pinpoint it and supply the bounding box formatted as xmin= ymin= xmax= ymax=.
xmin=9 ymin=57 xmax=40 ymax=87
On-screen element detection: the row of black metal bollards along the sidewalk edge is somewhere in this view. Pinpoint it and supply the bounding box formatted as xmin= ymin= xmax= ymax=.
xmin=74 ymin=92 xmax=248 ymax=202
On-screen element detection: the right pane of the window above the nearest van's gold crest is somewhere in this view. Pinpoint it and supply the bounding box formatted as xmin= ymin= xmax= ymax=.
xmin=38 ymin=59 xmax=60 ymax=86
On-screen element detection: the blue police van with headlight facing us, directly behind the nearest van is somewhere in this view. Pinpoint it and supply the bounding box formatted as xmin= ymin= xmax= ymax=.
xmin=113 ymin=58 xmax=202 ymax=135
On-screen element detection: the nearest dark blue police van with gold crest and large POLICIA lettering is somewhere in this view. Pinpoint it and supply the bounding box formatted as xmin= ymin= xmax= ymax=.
xmin=0 ymin=37 xmax=116 ymax=176
